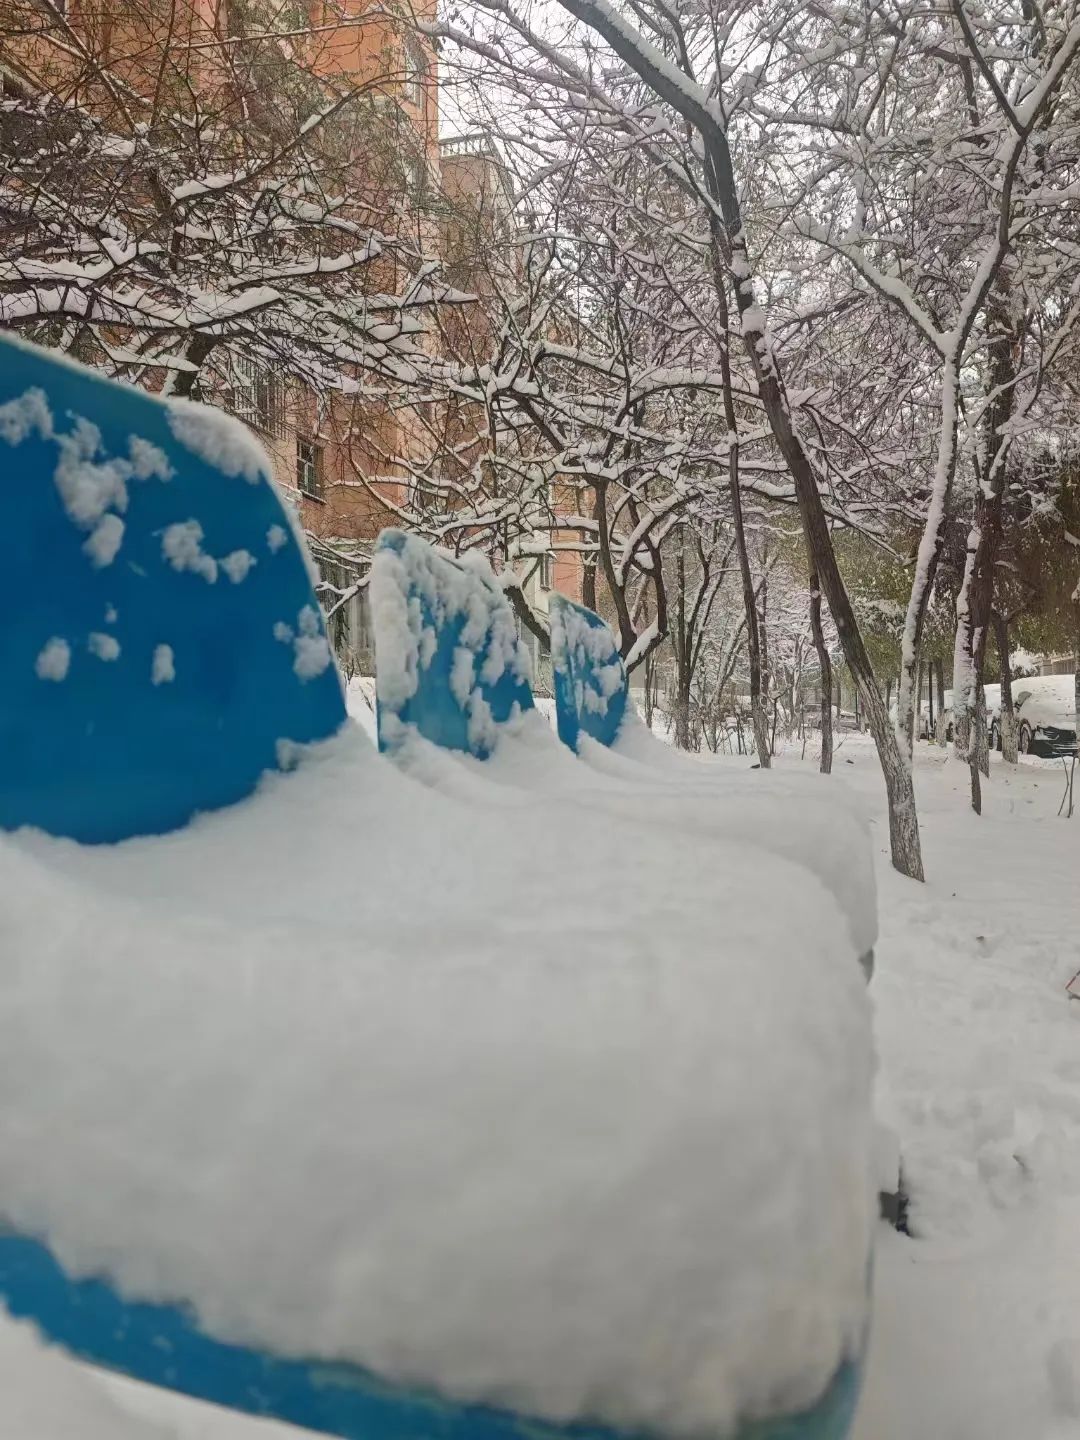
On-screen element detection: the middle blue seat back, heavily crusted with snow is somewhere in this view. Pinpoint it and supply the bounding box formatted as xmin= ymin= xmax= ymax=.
xmin=370 ymin=530 xmax=533 ymax=760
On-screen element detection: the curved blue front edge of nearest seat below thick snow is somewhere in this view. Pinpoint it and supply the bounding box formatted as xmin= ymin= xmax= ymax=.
xmin=0 ymin=1234 xmax=860 ymax=1440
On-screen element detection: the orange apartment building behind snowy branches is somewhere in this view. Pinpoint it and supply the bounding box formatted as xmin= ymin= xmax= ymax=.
xmin=0 ymin=0 xmax=580 ymax=668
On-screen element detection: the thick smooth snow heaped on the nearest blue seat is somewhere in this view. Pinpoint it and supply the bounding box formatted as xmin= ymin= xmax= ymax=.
xmin=0 ymin=727 xmax=873 ymax=1433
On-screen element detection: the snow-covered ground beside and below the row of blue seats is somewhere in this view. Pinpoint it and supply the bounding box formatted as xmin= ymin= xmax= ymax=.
xmin=8 ymin=736 xmax=1080 ymax=1440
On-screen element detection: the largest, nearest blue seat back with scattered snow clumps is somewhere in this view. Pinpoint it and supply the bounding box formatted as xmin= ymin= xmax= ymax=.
xmin=0 ymin=336 xmax=344 ymax=842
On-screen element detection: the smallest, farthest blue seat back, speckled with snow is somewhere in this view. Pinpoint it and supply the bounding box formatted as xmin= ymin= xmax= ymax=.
xmin=550 ymin=595 xmax=629 ymax=750
